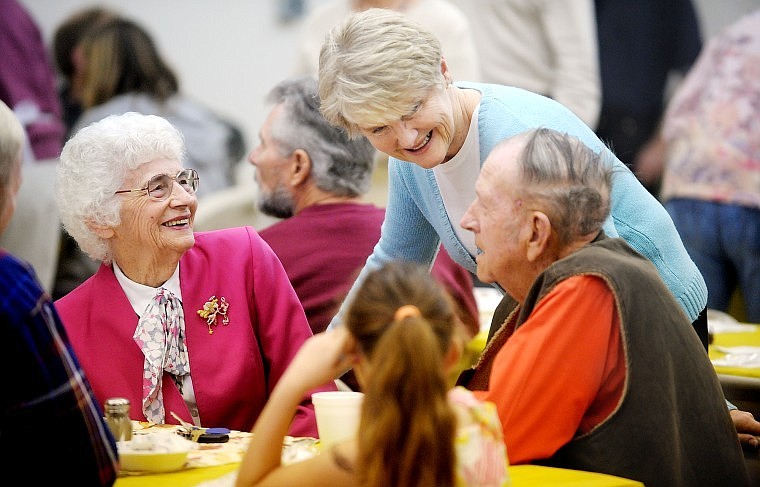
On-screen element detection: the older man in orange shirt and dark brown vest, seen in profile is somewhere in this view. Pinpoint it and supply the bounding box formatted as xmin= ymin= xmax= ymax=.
xmin=460 ymin=128 xmax=749 ymax=487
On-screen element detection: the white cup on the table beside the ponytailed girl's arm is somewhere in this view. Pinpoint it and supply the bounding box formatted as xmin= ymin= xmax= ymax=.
xmin=311 ymin=391 xmax=364 ymax=448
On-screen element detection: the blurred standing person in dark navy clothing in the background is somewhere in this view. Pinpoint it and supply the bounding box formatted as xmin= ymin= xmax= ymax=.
xmin=594 ymin=0 xmax=702 ymax=196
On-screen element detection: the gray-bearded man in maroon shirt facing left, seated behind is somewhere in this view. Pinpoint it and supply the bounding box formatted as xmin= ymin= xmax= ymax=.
xmin=248 ymin=77 xmax=480 ymax=339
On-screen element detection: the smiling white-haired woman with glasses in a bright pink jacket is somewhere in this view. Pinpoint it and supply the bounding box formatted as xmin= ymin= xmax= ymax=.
xmin=50 ymin=113 xmax=334 ymax=436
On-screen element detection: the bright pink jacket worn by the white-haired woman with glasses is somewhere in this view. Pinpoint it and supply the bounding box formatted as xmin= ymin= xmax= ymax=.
xmin=55 ymin=227 xmax=335 ymax=436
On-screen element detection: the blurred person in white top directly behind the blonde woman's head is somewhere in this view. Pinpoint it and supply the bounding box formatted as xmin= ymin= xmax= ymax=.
xmin=294 ymin=0 xmax=480 ymax=81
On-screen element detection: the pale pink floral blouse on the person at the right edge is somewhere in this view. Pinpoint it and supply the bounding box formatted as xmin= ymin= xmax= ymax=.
xmin=662 ymin=10 xmax=760 ymax=208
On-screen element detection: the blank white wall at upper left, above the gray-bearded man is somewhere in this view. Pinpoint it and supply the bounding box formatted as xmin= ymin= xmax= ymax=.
xmin=21 ymin=0 xmax=326 ymax=184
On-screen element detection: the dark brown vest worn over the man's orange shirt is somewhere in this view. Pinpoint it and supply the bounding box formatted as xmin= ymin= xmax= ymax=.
xmin=459 ymin=236 xmax=749 ymax=487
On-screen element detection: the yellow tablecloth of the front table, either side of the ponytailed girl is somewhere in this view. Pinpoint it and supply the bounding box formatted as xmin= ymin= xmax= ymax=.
xmin=115 ymin=463 xmax=644 ymax=487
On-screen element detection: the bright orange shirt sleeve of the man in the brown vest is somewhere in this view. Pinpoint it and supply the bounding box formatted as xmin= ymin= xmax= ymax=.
xmin=475 ymin=276 xmax=626 ymax=464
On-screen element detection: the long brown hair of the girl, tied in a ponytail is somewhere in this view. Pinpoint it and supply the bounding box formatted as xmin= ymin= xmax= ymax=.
xmin=346 ymin=262 xmax=456 ymax=487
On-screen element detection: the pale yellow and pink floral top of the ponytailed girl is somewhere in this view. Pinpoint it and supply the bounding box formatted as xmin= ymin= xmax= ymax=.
xmin=449 ymin=386 xmax=510 ymax=487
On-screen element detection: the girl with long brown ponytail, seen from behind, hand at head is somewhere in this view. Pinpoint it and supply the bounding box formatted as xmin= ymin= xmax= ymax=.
xmin=237 ymin=262 xmax=509 ymax=487
